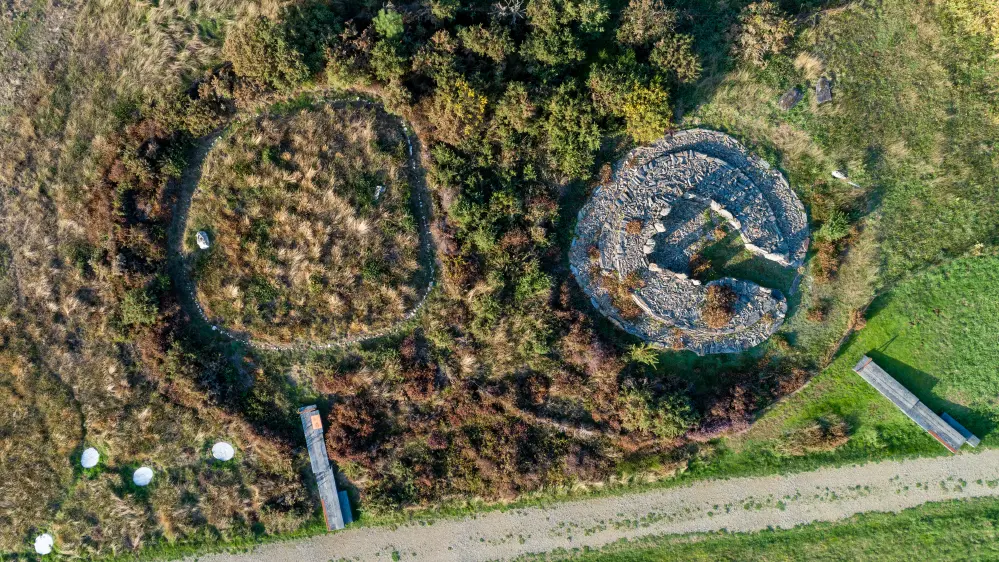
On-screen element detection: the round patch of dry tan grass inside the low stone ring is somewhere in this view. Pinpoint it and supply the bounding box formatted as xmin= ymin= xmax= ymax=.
xmin=184 ymin=103 xmax=429 ymax=345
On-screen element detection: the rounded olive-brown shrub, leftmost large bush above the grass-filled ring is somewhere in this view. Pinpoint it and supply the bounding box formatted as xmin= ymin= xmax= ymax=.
xmin=222 ymin=16 xmax=309 ymax=88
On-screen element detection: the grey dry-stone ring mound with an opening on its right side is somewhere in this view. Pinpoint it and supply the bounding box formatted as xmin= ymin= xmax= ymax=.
xmin=569 ymin=129 xmax=808 ymax=355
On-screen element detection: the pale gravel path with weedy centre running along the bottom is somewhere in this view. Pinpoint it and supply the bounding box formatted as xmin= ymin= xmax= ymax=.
xmin=184 ymin=450 xmax=999 ymax=562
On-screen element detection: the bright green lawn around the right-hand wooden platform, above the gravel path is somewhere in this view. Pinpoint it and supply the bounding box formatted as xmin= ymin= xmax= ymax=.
xmin=709 ymin=254 xmax=999 ymax=472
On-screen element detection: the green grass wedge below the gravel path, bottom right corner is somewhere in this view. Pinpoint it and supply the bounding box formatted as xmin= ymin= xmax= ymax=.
xmin=528 ymin=498 xmax=999 ymax=562
